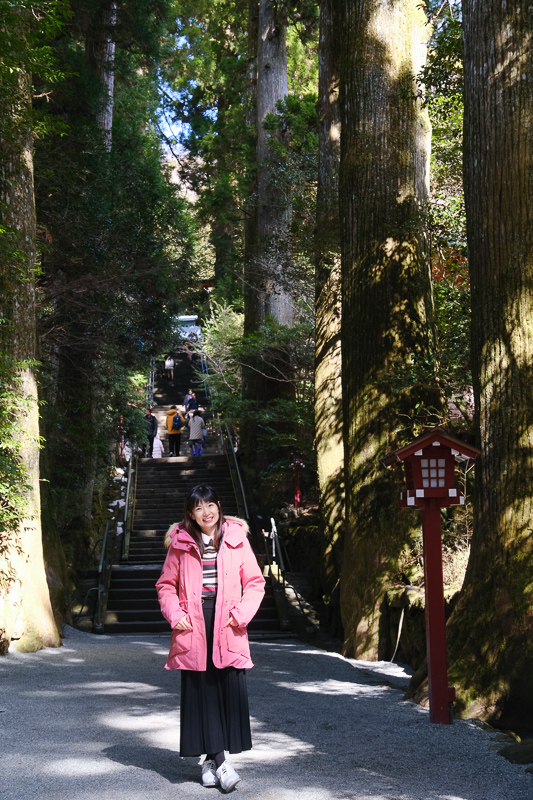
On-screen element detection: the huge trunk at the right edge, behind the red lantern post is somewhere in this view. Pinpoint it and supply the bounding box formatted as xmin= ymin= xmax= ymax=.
xmin=442 ymin=0 xmax=533 ymax=729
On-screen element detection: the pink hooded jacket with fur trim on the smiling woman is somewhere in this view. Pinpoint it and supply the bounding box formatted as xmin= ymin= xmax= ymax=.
xmin=156 ymin=518 xmax=265 ymax=671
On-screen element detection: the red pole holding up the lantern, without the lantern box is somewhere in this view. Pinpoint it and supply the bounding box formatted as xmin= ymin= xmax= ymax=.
xmin=422 ymin=499 xmax=455 ymax=725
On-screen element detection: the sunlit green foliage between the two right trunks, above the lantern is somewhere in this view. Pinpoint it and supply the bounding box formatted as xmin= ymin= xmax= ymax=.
xmin=419 ymin=0 xmax=472 ymax=410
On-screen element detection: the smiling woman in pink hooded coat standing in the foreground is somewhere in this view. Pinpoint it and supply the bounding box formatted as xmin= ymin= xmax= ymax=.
xmin=156 ymin=486 xmax=265 ymax=792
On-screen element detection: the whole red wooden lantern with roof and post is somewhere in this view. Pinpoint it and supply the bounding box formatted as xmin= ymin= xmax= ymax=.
xmin=383 ymin=428 xmax=480 ymax=725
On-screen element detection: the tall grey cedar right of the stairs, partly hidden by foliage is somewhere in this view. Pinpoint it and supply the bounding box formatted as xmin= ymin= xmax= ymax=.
xmin=242 ymin=0 xmax=294 ymax=473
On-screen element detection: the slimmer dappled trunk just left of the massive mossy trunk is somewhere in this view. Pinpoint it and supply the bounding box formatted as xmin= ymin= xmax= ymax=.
xmin=315 ymin=0 xmax=344 ymax=624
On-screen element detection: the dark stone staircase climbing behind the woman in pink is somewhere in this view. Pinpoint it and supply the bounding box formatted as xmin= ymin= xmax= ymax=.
xmin=104 ymin=346 xmax=280 ymax=634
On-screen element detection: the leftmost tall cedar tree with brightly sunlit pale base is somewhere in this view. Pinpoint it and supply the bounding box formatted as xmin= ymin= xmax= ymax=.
xmin=0 ymin=4 xmax=61 ymax=654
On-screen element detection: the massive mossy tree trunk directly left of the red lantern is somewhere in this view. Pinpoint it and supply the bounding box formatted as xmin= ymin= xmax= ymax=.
xmin=339 ymin=0 xmax=438 ymax=658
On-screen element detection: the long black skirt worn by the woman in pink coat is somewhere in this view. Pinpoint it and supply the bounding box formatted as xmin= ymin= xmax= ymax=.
xmin=180 ymin=598 xmax=252 ymax=756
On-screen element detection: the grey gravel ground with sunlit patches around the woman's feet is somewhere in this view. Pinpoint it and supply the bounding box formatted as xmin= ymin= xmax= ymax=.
xmin=0 ymin=629 xmax=533 ymax=800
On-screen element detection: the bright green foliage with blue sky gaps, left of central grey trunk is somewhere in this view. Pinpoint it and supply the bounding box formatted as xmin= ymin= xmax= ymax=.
xmin=160 ymin=0 xmax=250 ymax=300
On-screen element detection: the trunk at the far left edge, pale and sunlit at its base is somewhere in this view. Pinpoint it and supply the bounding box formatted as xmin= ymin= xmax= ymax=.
xmin=0 ymin=67 xmax=61 ymax=652
